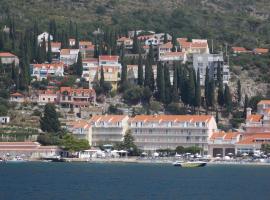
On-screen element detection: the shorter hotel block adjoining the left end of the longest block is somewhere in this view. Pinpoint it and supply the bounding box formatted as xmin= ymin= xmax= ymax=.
xmin=90 ymin=115 xmax=128 ymax=146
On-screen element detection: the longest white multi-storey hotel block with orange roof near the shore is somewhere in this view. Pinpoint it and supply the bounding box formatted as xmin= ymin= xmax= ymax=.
xmin=129 ymin=115 xmax=217 ymax=154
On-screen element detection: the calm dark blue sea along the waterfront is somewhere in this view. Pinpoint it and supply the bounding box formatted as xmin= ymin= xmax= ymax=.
xmin=0 ymin=163 xmax=270 ymax=200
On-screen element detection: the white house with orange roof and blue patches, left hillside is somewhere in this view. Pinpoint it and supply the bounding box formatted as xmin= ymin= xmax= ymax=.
xmin=30 ymin=62 xmax=64 ymax=81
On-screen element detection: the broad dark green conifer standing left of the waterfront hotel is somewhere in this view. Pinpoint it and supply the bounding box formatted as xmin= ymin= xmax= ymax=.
xmin=40 ymin=104 xmax=61 ymax=133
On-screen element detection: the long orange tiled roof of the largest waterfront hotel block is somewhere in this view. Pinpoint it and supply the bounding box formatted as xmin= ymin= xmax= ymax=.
xmin=130 ymin=115 xmax=213 ymax=122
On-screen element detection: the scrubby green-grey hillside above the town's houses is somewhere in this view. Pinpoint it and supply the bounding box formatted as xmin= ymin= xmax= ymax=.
xmin=0 ymin=0 xmax=270 ymax=47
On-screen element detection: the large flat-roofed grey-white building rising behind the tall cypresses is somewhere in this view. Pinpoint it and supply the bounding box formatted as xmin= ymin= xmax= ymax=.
xmin=193 ymin=53 xmax=230 ymax=86
